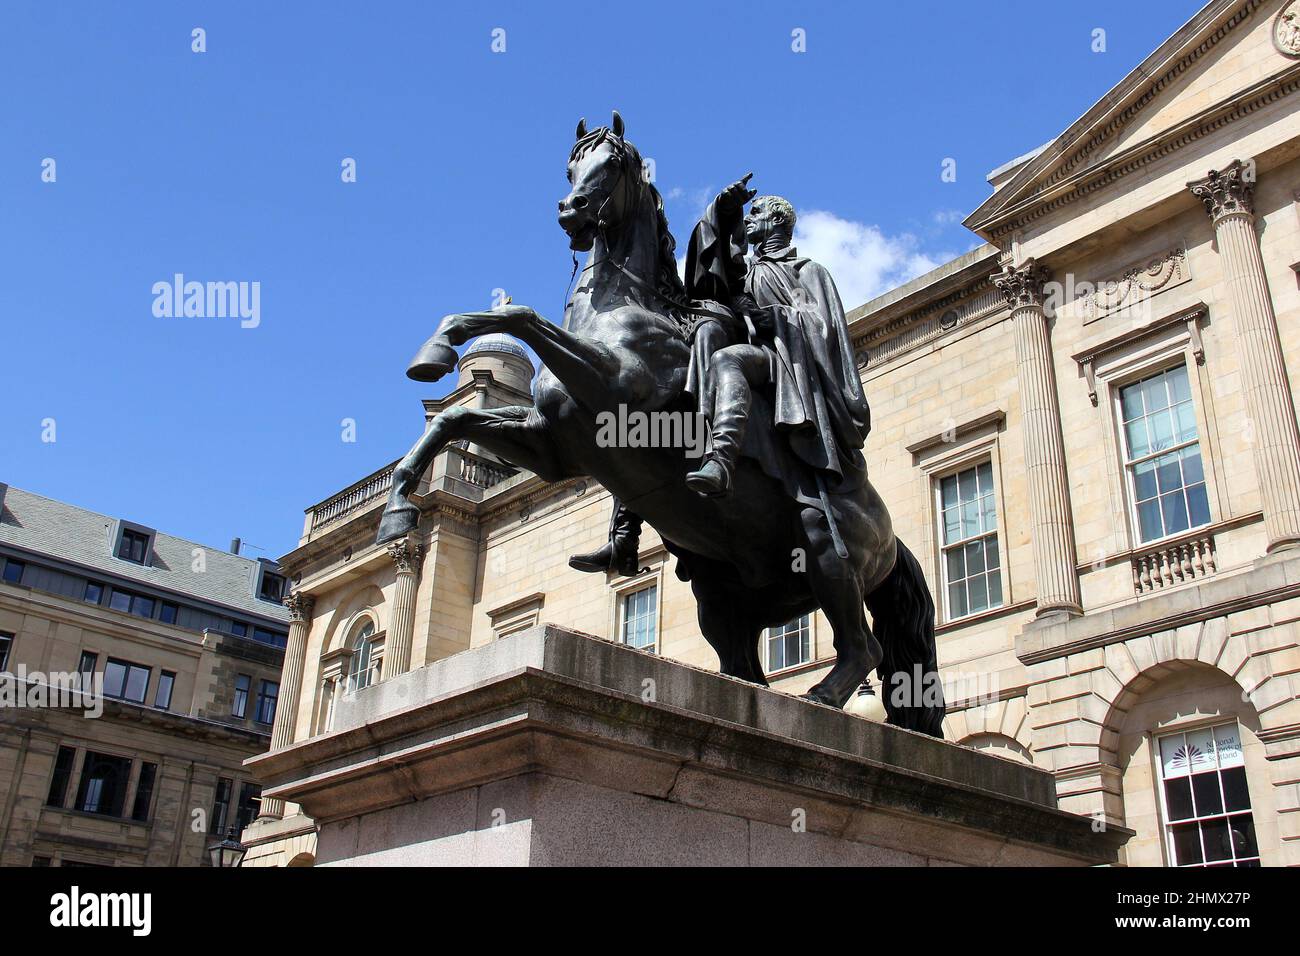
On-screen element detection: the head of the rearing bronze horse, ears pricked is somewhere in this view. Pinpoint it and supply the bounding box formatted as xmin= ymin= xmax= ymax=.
xmin=559 ymin=111 xmax=646 ymax=251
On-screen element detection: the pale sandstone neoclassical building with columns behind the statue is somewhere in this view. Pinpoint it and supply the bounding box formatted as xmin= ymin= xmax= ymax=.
xmin=244 ymin=0 xmax=1300 ymax=866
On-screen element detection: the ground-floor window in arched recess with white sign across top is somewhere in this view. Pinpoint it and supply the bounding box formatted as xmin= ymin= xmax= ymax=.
xmin=1158 ymin=721 xmax=1260 ymax=866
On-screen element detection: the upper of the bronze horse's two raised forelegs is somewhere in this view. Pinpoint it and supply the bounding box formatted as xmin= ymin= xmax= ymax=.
xmin=407 ymin=304 xmax=623 ymax=410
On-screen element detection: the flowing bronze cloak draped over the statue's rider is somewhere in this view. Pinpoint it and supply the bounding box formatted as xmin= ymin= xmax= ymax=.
xmin=686 ymin=203 xmax=871 ymax=507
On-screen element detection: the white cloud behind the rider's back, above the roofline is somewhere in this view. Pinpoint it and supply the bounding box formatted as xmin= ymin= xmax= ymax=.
xmin=794 ymin=209 xmax=953 ymax=312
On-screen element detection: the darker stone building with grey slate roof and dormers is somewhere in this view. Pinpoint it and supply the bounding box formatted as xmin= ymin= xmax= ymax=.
xmin=0 ymin=484 xmax=289 ymax=866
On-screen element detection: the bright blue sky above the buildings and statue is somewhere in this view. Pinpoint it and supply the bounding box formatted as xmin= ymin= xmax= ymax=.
xmin=0 ymin=0 xmax=1200 ymax=557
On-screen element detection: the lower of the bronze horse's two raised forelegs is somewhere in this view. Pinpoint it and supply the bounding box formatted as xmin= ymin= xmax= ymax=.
xmin=374 ymin=405 xmax=568 ymax=544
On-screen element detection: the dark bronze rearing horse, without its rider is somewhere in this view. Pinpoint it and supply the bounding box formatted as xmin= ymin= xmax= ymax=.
xmin=377 ymin=113 xmax=944 ymax=736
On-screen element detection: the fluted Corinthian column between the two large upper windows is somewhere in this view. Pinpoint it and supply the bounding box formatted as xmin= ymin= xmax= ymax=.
xmin=993 ymin=259 xmax=1080 ymax=617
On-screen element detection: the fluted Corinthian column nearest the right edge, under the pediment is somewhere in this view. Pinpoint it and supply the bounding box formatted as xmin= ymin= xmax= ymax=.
xmin=1187 ymin=160 xmax=1300 ymax=551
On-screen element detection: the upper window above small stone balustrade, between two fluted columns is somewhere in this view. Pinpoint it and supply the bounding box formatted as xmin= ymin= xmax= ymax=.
xmin=1117 ymin=364 xmax=1210 ymax=542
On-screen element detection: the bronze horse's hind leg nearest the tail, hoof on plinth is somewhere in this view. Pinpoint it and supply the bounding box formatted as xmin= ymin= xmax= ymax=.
xmin=802 ymin=507 xmax=884 ymax=708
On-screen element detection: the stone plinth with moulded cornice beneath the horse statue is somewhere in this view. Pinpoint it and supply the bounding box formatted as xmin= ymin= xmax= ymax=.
xmin=250 ymin=626 xmax=1131 ymax=866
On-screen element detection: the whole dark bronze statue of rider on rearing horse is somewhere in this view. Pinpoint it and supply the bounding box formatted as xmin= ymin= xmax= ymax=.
xmin=377 ymin=113 xmax=944 ymax=736
